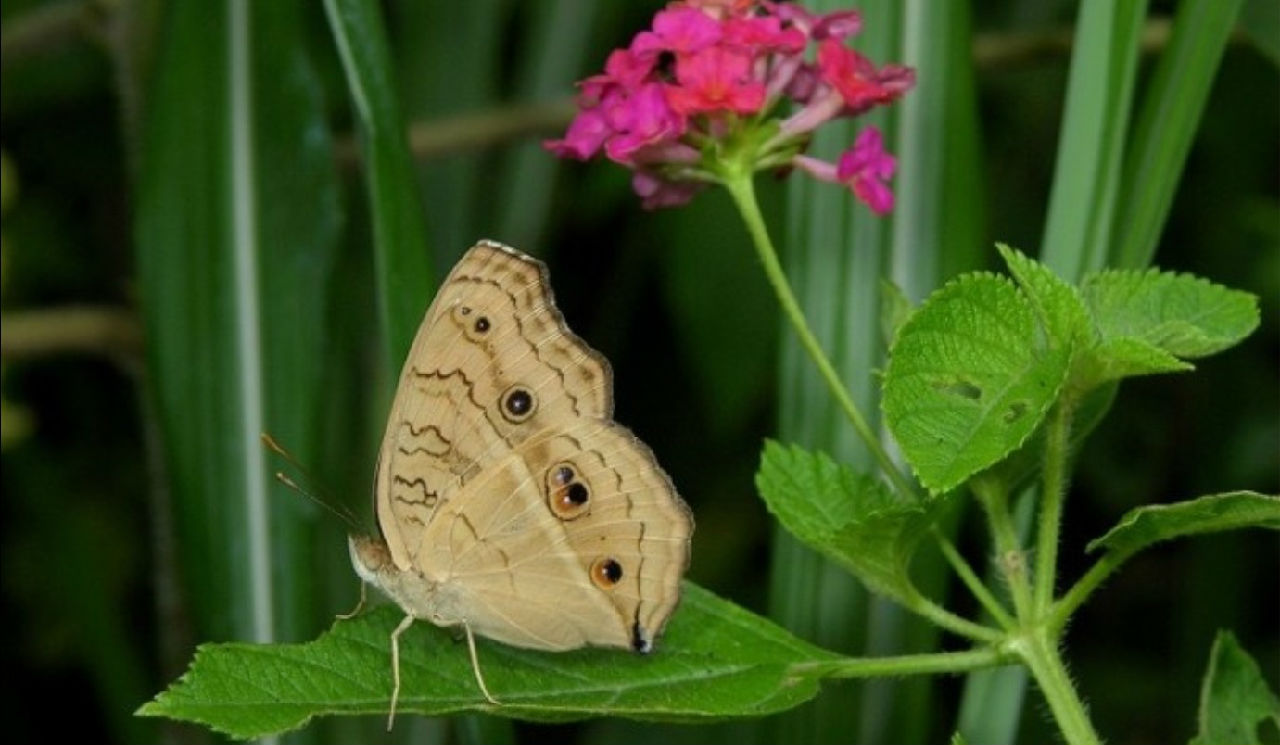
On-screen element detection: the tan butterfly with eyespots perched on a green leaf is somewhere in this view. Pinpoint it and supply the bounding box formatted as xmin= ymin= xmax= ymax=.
xmin=349 ymin=241 xmax=694 ymax=728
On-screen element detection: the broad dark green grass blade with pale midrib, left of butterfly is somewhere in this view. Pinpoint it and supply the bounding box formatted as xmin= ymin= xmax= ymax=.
xmin=137 ymin=0 xmax=338 ymax=655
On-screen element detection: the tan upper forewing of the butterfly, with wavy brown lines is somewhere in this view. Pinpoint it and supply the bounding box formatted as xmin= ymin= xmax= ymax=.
xmin=374 ymin=243 xmax=613 ymax=570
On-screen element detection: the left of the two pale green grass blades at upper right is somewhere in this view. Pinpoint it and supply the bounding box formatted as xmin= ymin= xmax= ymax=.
xmin=1041 ymin=0 xmax=1147 ymax=282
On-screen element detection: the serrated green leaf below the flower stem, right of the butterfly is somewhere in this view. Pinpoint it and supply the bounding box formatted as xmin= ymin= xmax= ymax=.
xmin=755 ymin=440 xmax=932 ymax=600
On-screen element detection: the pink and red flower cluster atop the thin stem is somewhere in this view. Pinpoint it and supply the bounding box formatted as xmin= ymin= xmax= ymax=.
xmin=545 ymin=0 xmax=915 ymax=214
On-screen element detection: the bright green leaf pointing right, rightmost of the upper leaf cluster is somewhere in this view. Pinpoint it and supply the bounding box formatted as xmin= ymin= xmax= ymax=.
xmin=1080 ymin=269 xmax=1258 ymax=360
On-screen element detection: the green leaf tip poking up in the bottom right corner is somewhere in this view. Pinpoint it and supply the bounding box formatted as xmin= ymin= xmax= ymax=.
xmin=1192 ymin=631 xmax=1280 ymax=745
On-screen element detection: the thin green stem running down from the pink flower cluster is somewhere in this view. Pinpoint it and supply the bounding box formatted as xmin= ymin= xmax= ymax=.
xmin=721 ymin=165 xmax=915 ymax=497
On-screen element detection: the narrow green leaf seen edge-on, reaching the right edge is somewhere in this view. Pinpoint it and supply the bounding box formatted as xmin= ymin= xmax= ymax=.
xmin=1088 ymin=492 xmax=1280 ymax=556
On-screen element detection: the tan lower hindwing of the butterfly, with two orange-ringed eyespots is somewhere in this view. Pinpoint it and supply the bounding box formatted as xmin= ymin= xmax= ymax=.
xmin=419 ymin=419 xmax=692 ymax=652
